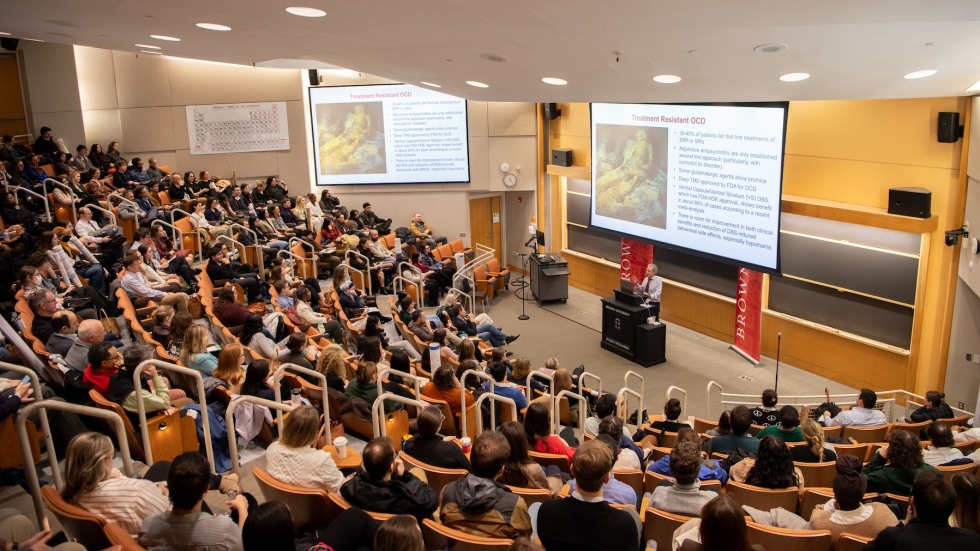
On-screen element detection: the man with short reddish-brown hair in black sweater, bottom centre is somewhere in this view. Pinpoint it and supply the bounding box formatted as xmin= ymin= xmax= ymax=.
xmin=530 ymin=440 xmax=640 ymax=551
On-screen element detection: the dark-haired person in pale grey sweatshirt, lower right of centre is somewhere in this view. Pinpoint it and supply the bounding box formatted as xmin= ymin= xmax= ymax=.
xmin=650 ymin=441 xmax=718 ymax=517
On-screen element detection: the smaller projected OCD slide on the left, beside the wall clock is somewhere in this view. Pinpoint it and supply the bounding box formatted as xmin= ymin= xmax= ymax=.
xmin=310 ymin=85 xmax=470 ymax=186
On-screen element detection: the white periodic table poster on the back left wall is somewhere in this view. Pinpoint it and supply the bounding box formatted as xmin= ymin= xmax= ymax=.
xmin=187 ymin=101 xmax=289 ymax=155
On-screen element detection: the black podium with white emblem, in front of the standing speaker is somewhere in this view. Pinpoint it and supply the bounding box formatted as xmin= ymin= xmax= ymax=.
xmin=601 ymin=297 xmax=667 ymax=367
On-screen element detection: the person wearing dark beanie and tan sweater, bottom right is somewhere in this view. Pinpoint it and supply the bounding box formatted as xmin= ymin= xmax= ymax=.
xmin=810 ymin=455 xmax=898 ymax=545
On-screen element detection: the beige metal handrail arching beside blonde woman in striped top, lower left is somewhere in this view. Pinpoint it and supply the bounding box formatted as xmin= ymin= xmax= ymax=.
xmin=17 ymin=402 xmax=133 ymax=530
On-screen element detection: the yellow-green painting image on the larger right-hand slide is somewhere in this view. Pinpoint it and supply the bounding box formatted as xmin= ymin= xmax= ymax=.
xmin=592 ymin=124 xmax=667 ymax=228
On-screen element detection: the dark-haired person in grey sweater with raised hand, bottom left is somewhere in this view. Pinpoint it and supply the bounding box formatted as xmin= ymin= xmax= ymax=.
xmin=138 ymin=452 xmax=248 ymax=551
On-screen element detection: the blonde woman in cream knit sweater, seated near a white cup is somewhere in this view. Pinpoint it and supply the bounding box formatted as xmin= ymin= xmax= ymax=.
xmin=265 ymin=406 xmax=344 ymax=492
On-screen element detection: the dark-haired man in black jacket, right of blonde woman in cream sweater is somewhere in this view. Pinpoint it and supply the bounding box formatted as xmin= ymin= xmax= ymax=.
xmin=340 ymin=436 xmax=439 ymax=521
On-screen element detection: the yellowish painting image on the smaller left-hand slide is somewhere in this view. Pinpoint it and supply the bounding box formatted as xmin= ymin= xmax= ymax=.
xmin=316 ymin=101 xmax=387 ymax=175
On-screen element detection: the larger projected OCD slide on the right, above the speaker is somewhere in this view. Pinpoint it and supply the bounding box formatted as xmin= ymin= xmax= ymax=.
xmin=590 ymin=103 xmax=787 ymax=270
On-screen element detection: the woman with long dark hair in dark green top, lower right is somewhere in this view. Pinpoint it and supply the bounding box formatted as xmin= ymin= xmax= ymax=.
xmin=862 ymin=430 xmax=936 ymax=496
